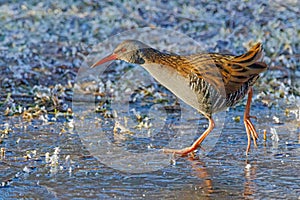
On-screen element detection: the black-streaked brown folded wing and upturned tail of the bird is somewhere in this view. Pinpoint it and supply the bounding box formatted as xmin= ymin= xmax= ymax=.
xmin=188 ymin=43 xmax=267 ymax=94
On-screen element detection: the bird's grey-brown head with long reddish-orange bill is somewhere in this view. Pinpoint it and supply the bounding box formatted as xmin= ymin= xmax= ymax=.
xmin=91 ymin=40 xmax=151 ymax=68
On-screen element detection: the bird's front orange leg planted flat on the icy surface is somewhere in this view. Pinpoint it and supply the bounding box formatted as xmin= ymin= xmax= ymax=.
xmin=163 ymin=116 xmax=215 ymax=156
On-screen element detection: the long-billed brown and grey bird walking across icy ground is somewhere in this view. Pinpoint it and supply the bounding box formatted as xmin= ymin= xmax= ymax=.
xmin=91 ymin=39 xmax=268 ymax=156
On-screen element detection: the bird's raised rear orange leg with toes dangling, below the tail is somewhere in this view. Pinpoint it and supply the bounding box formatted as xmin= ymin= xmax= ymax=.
xmin=244 ymin=88 xmax=258 ymax=154
